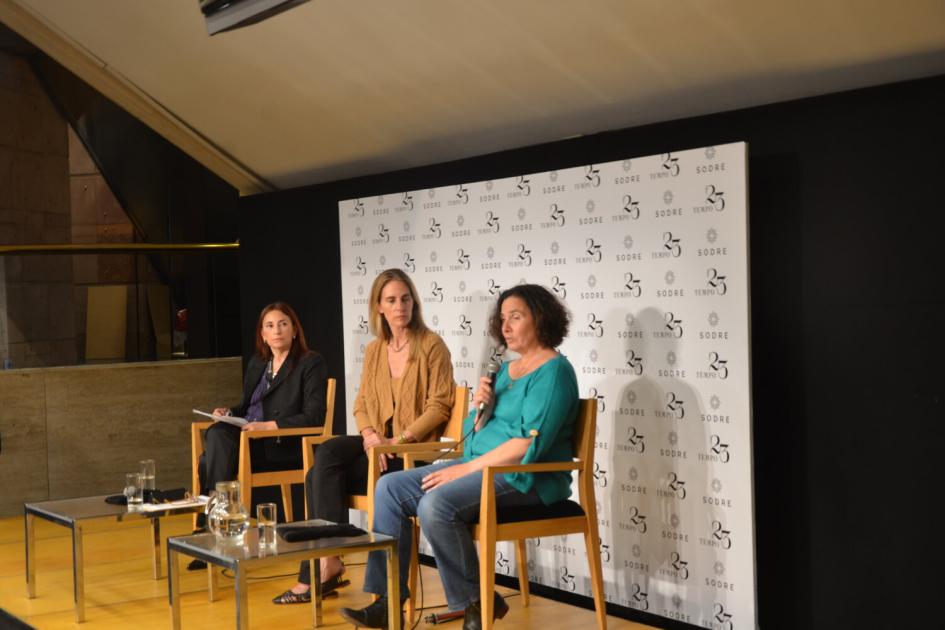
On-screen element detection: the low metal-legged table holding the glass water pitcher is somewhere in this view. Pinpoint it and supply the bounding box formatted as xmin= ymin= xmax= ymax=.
xmin=167 ymin=520 xmax=400 ymax=630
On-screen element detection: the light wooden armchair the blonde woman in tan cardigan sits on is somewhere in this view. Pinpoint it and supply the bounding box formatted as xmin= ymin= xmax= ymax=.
xmin=302 ymin=386 xmax=469 ymax=529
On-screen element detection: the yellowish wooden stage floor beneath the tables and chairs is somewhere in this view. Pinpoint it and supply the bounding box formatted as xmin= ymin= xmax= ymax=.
xmin=0 ymin=516 xmax=652 ymax=630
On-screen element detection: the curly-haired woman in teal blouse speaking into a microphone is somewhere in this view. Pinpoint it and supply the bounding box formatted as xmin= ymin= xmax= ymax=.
xmin=340 ymin=284 xmax=578 ymax=630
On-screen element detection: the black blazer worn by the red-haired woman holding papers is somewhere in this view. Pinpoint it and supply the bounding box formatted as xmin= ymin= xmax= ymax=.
xmin=230 ymin=352 xmax=328 ymax=461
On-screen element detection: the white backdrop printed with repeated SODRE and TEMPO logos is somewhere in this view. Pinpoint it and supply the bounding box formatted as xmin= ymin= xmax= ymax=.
xmin=339 ymin=143 xmax=756 ymax=630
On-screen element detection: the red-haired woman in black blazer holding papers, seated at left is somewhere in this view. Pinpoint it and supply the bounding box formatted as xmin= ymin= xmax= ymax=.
xmin=199 ymin=302 xmax=327 ymax=509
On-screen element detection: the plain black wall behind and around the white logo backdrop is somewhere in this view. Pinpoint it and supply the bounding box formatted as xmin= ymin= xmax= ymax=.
xmin=240 ymin=77 xmax=945 ymax=629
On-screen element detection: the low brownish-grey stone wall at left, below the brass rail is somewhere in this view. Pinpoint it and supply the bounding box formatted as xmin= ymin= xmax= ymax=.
xmin=0 ymin=358 xmax=242 ymax=516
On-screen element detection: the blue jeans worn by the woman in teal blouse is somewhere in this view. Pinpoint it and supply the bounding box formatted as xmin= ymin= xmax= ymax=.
xmin=364 ymin=460 xmax=541 ymax=610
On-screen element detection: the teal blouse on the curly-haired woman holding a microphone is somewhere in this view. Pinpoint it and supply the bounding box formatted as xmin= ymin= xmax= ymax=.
xmin=463 ymin=354 xmax=578 ymax=505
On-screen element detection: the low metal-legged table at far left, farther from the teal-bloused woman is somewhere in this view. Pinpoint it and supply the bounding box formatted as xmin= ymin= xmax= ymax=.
xmin=23 ymin=495 xmax=203 ymax=623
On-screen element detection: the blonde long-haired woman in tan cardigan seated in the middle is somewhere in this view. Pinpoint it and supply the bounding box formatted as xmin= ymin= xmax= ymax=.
xmin=273 ymin=269 xmax=455 ymax=604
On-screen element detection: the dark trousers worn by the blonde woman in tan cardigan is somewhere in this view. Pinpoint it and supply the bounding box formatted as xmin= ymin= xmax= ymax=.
xmin=299 ymin=435 xmax=404 ymax=584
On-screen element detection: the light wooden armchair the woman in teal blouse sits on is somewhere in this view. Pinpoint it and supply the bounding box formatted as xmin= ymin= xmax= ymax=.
xmin=407 ymin=399 xmax=607 ymax=630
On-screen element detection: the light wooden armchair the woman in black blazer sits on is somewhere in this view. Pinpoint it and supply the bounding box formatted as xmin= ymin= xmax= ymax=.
xmin=190 ymin=378 xmax=337 ymax=526
